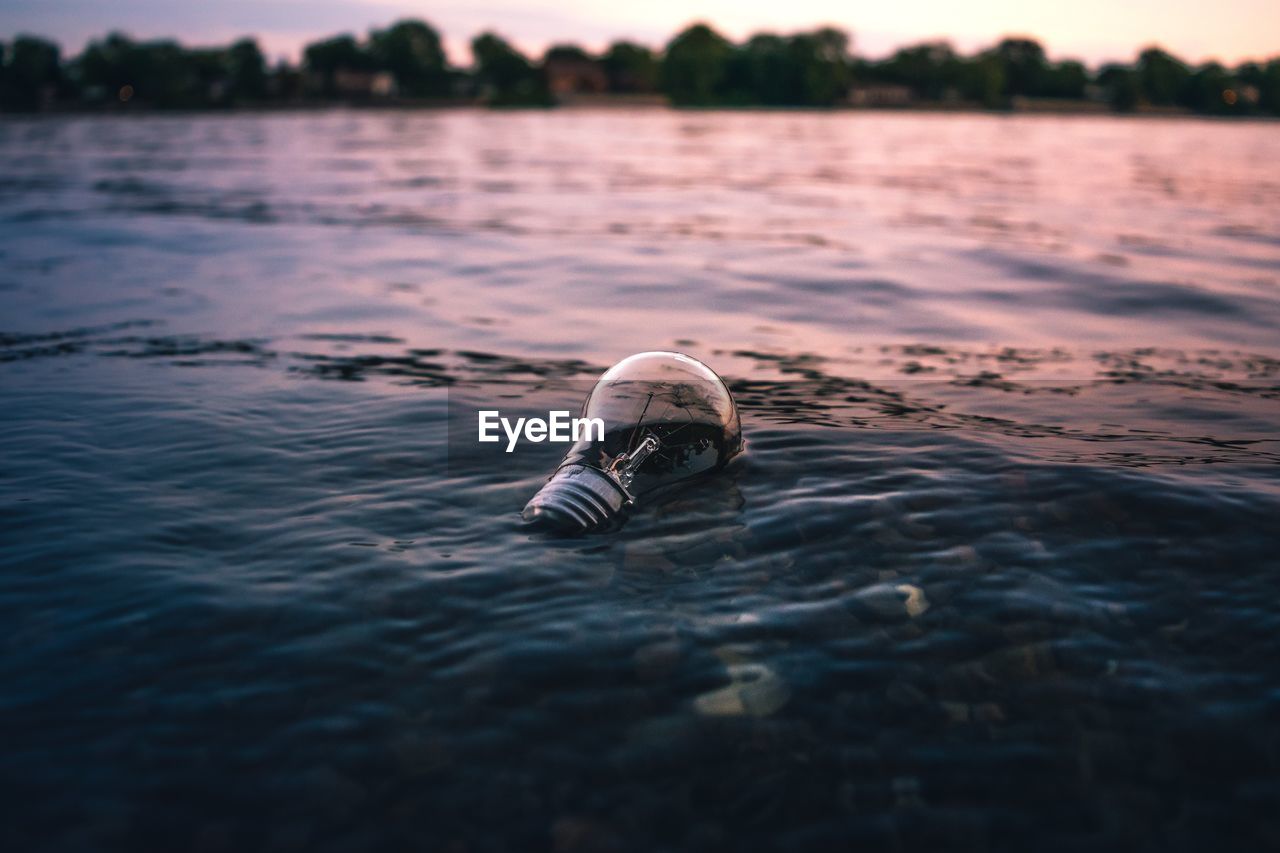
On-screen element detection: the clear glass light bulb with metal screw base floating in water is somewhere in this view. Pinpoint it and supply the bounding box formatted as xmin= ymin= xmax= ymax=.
xmin=524 ymin=352 xmax=742 ymax=532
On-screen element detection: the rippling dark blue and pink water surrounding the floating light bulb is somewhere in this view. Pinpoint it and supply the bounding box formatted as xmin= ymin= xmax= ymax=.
xmin=0 ymin=110 xmax=1280 ymax=850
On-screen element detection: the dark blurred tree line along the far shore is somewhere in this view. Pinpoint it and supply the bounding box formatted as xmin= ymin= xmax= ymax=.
xmin=0 ymin=20 xmax=1280 ymax=115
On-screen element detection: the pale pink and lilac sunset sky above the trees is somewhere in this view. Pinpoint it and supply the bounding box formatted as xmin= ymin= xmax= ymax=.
xmin=0 ymin=0 xmax=1280 ymax=64
